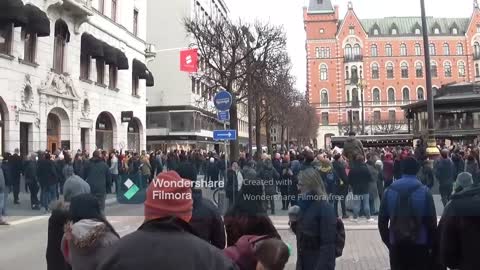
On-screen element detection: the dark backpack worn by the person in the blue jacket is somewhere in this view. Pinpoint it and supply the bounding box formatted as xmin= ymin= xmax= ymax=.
xmin=390 ymin=184 xmax=422 ymax=245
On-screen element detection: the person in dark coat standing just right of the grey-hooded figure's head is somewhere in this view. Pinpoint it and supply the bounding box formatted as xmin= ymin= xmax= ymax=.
xmin=85 ymin=150 xmax=110 ymax=212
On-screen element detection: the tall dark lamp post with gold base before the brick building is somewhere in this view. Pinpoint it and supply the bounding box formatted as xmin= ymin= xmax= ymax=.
xmin=420 ymin=0 xmax=440 ymax=156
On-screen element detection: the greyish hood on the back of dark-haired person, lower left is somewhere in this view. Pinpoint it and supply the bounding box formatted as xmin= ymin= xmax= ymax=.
xmin=65 ymin=219 xmax=109 ymax=249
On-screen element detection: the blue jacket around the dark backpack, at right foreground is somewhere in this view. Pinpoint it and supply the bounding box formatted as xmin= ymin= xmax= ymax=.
xmin=378 ymin=175 xmax=437 ymax=247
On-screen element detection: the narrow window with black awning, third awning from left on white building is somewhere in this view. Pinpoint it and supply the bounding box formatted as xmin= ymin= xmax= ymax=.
xmin=53 ymin=20 xmax=70 ymax=73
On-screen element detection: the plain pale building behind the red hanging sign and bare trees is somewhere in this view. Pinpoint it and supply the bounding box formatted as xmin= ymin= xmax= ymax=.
xmin=147 ymin=0 xmax=248 ymax=151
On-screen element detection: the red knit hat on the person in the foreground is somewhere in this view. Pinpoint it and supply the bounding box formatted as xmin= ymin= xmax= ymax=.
xmin=145 ymin=171 xmax=193 ymax=222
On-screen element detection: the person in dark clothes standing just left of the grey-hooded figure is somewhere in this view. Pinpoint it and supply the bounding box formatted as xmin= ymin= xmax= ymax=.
xmin=37 ymin=152 xmax=59 ymax=212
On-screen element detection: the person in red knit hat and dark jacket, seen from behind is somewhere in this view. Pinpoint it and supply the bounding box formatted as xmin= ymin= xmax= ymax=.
xmin=96 ymin=171 xmax=235 ymax=270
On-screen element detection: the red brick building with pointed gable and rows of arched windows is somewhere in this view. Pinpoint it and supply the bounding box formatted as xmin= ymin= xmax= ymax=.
xmin=303 ymin=0 xmax=480 ymax=147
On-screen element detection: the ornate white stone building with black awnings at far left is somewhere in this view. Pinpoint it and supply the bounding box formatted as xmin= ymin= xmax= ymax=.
xmin=0 ymin=0 xmax=154 ymax=154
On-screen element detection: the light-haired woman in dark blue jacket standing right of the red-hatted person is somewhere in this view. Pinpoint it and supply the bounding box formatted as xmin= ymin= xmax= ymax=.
xmin=289 ymin=167 xmax=337 ymax=270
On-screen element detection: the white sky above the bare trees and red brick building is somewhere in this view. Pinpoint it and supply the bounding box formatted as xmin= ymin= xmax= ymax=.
xmin=225 ymin=0 xmax=473 ymax=92
